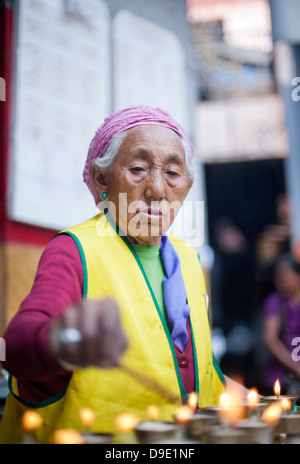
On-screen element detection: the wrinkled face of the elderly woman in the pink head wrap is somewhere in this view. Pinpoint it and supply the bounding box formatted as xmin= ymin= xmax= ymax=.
xmin=97 ymin=125 xmax=192 ymax=246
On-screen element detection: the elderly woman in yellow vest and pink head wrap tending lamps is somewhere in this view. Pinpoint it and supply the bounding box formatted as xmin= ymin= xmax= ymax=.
xmin=1 ymin=106 xmax=224 ymax=442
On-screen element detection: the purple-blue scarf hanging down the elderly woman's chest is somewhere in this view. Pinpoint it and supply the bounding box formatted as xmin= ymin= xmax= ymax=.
xmin=160 ymin=235 xmax=190 ymax=351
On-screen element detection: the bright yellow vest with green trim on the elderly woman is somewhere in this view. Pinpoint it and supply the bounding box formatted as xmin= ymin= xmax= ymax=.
xmin=0 ymin=214 xmax=224 ymax=443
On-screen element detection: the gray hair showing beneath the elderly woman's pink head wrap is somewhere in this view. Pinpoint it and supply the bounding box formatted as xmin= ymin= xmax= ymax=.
xmin=92 ymin=131 xmax=194 ymax=180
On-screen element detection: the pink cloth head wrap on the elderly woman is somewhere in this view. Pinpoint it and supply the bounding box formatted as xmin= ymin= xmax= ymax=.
xmin=83 ymin=105 xmax=193 ymax=202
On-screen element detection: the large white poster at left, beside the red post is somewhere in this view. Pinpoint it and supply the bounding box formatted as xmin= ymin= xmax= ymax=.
xmin=9 ymin=0 xmax=111 ymax=229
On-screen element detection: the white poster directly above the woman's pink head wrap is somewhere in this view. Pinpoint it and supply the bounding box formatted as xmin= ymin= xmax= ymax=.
xmin=113 ymin=10 xmax=189 ymax=133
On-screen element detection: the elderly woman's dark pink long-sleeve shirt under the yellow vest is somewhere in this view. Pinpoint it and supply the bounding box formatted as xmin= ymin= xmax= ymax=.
xmin=2 ymin=235 xmax=195 ymax=402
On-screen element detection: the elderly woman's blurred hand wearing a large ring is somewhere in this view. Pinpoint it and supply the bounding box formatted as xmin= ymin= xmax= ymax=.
xmin=48 ymin=299 xmax=127 ymax=370
